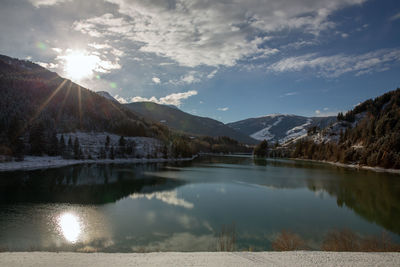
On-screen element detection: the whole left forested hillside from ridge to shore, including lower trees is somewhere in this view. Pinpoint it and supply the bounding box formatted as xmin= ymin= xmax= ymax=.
xmin=0 ymin=55 xmax=248 ymax=161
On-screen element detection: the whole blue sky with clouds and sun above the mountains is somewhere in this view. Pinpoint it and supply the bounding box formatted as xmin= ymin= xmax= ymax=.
xmin=0 ymin=0 xmax=400 ymax=123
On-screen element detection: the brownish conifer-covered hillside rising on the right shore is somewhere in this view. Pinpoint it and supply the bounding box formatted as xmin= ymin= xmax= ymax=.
xmin=292 ymin=89 xmax=400 ymax=169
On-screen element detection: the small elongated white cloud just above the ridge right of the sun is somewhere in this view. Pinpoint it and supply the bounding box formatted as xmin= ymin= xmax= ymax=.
xmin=120 ymin=90 xmax=197 ymax=107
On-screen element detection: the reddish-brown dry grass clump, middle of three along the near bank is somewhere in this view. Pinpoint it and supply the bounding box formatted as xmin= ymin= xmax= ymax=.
xmin=272 ymin=230 xmax=307 ymax=251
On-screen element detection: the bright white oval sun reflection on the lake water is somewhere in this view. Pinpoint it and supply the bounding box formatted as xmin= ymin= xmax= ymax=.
xmin=58 ymin=212 xmax=82 ymax=243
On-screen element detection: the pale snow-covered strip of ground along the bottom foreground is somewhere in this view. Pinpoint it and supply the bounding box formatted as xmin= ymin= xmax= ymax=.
xmin=0 ymin=251 xmax=400 ymax=267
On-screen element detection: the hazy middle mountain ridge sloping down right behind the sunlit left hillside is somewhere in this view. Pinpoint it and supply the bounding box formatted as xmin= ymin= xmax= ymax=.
xmin=125 ymin=102 xmax=258 ymax=144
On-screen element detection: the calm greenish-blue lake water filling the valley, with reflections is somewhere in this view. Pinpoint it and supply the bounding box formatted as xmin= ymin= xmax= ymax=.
xmin=0 ymin=156 xmax=400 ymax=252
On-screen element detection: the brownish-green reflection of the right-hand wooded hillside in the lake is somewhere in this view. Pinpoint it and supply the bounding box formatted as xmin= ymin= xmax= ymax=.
xmin=308 ymin=172 xmax=400 ymax=234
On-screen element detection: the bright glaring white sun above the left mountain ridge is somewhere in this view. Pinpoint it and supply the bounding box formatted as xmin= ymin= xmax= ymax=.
xmin=60 ymin=51 xmax=100 ymax=81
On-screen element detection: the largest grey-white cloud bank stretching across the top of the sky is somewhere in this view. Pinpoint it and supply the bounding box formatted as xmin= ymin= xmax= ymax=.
xmin=73 ymin=0 xmax=366 ymax=67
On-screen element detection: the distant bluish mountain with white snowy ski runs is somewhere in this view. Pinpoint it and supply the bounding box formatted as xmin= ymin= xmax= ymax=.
xmin=227 ymin=114 xmax=336 ymax=143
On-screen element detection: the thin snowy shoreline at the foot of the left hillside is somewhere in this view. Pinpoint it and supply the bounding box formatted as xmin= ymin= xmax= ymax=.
xmin=0 ymin=155 xmax=197 ymax=172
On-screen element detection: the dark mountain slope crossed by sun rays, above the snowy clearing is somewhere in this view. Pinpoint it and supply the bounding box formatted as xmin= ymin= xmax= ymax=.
xmin=0 ymin=55 xmax=168 ymax=154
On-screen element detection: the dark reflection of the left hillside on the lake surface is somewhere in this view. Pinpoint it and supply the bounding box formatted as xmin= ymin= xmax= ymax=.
xmin=0 ymin=164 xmax=183 ymax=204
